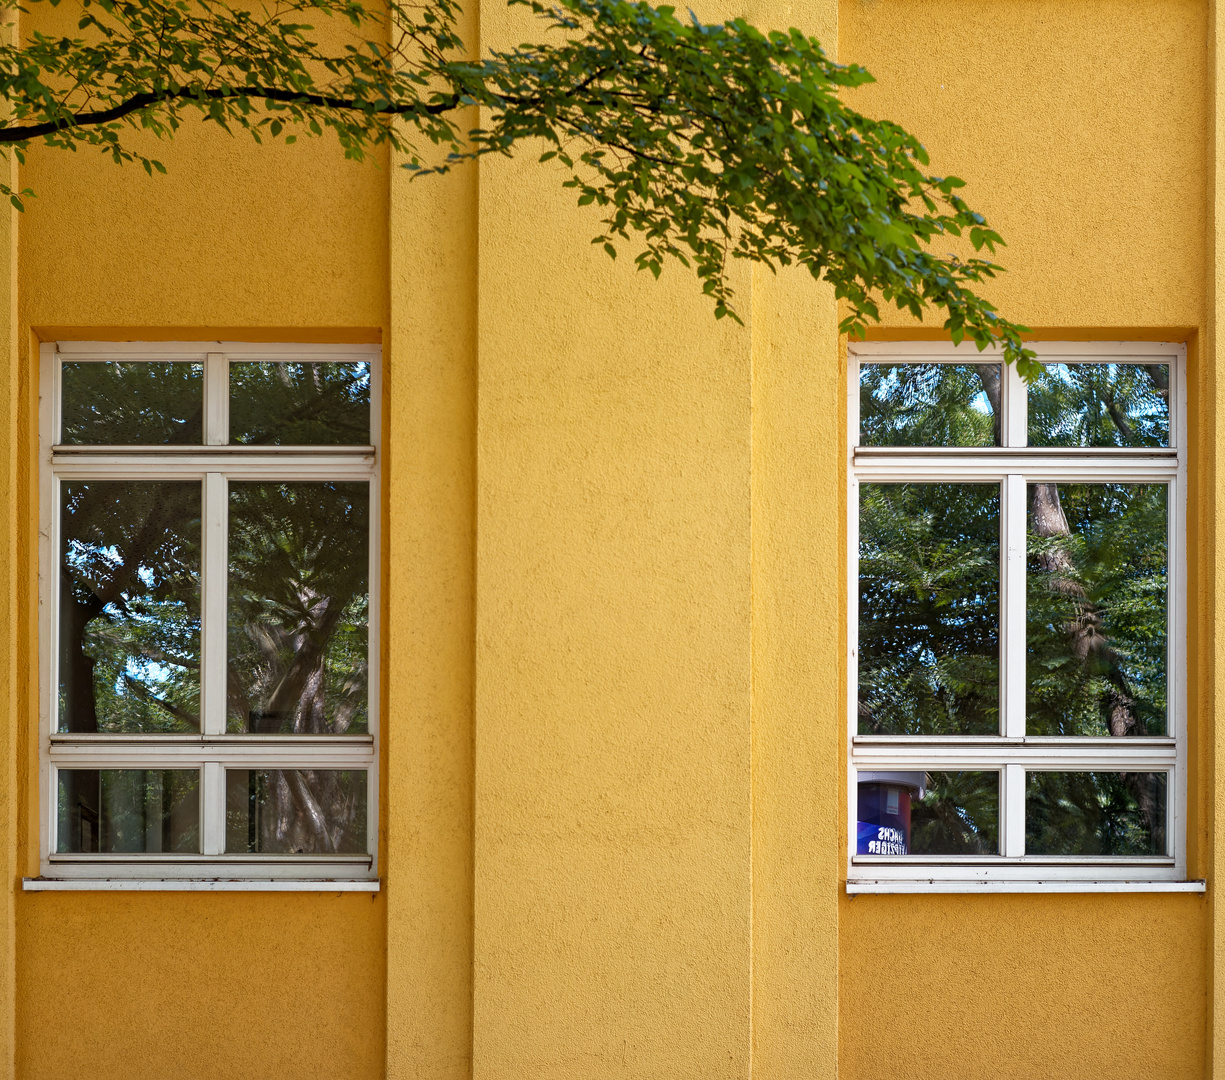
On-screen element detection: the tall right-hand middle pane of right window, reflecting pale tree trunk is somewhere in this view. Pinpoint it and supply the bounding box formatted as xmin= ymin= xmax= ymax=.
xmin=1025 ymin=484 xmax=1167 ymax=736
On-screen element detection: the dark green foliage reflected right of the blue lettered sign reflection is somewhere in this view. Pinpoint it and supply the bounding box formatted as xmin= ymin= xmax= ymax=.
xmin=910 ymin=771 xmax=1000 ymax=855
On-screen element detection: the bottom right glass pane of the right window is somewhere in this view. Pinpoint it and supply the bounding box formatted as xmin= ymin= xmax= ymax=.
xmin=1025 ymin=773 xmax=1166 ymax=855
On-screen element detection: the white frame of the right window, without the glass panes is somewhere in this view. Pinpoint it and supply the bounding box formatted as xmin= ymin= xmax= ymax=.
xmin=846 ymin=342 xmax=1203 ymax=893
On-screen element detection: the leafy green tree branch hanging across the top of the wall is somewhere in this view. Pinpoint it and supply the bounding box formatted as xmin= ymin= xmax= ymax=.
xmin=0 ymin=0 xmax=1036 ymax=376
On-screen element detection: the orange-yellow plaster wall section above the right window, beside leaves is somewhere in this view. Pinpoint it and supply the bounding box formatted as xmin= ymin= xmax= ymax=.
xmin=838 ymin=0 xmax=1209 ymax=328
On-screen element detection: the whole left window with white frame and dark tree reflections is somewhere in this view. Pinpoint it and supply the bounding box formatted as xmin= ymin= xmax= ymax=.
xmin=39 ymin=342 xmax=379 ymax=884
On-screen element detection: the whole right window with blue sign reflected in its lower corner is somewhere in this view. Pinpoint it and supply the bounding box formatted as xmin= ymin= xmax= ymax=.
xmin=848 ymin=343 xmax=1186 ymax=891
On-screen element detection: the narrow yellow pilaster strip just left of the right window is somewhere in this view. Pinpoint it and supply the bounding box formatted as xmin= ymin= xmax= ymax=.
xmin=750 ymin=0 xmax=846 ymax=1080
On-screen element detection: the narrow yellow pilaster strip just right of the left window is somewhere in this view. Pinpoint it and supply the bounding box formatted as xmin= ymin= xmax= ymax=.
xmin=382 ymin=18 xmax=479 ymax=1080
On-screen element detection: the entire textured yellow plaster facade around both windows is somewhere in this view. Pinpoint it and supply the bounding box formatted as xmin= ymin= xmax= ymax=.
xmin=0 ymin=0 xmax=1225 ymax=1080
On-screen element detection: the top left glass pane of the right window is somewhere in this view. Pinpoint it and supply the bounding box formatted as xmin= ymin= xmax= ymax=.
xmin=859 ymin=364 xmax=1001 ymax=446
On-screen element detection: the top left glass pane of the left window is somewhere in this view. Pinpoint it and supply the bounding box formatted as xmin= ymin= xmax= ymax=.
xmin=60 ymin=360 xmax=205 ymax=446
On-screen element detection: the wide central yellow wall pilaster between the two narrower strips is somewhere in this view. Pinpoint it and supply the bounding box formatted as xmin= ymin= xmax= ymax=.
xmin=473 ymin=5 xmax=752 ymax=1080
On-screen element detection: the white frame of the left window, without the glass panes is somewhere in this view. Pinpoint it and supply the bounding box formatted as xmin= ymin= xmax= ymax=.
xmin=34 ymin=342 xmax=382 ymax=889
